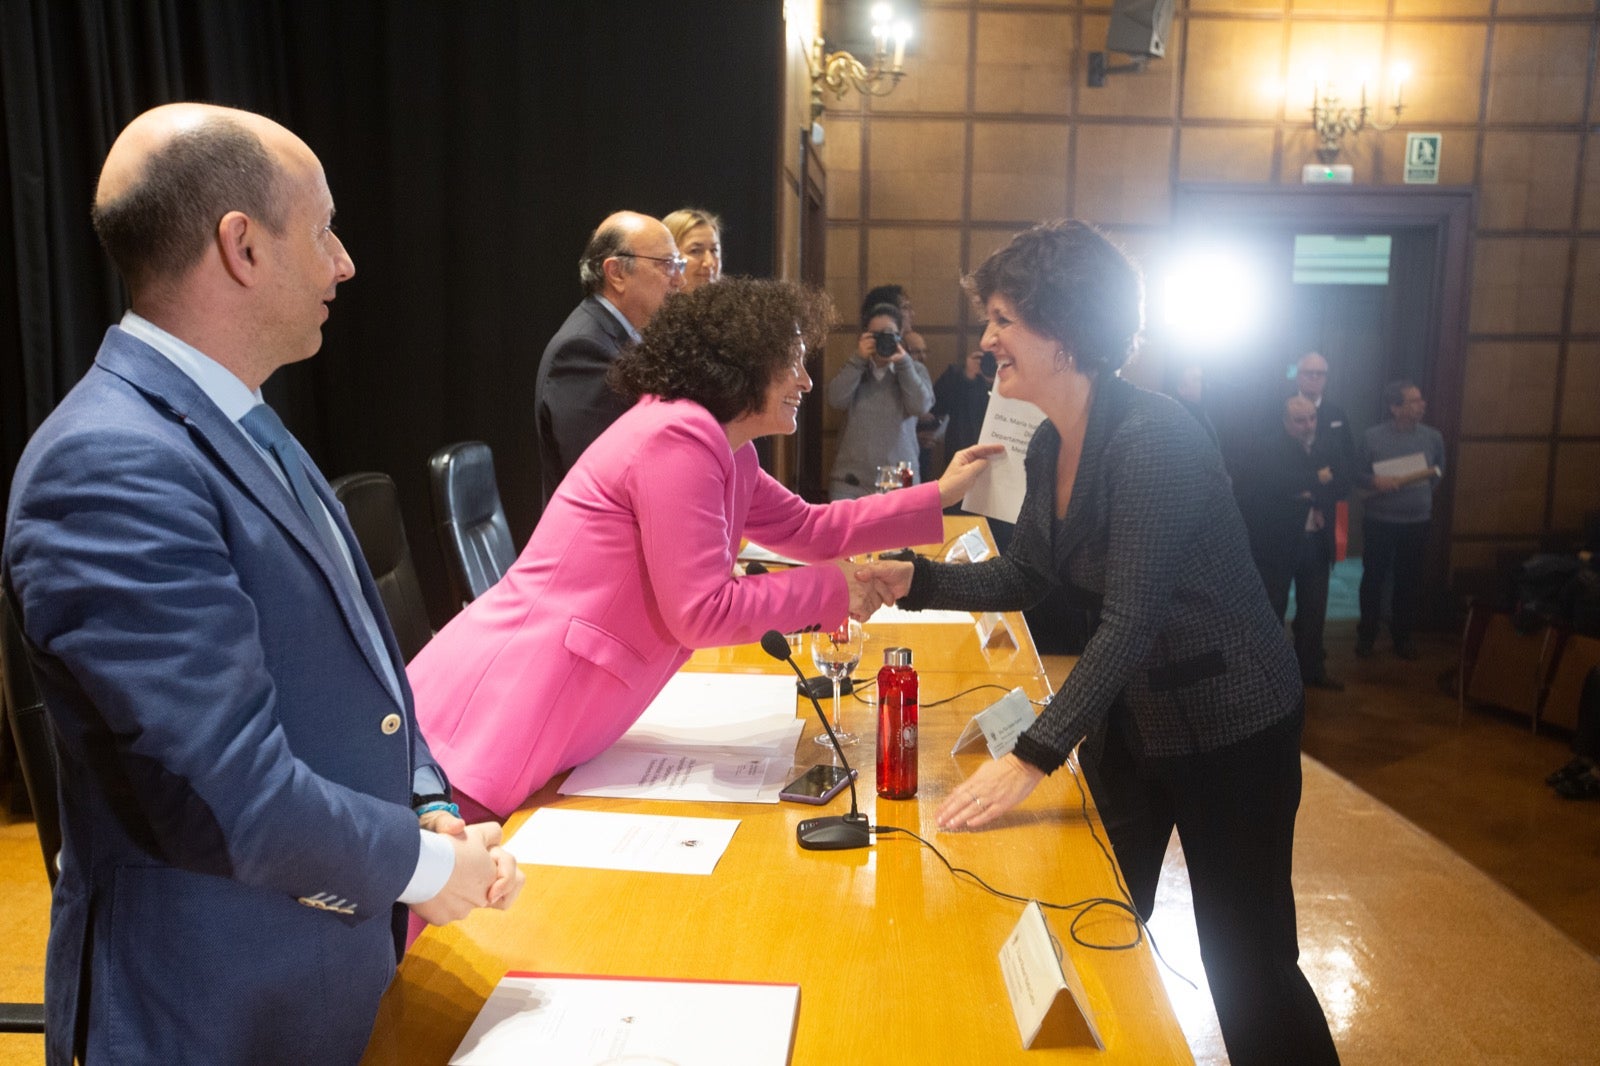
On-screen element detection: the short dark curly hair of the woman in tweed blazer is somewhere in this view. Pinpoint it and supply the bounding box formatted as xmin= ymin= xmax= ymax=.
xmin=962 ymin=219 xmax=1144 ymax=375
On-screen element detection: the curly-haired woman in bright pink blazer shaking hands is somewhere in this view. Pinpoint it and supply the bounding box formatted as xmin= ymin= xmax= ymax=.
xmin=408 ymin=279 xmax=995 ymax=816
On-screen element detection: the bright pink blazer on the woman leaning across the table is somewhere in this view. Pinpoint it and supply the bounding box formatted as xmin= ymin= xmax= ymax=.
xmin=406 ymin=397 xmax=944 ymax=816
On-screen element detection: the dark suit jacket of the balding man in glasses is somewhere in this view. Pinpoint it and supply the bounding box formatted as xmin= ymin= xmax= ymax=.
xmin=534 ymin=296 xmax=632 ymax=504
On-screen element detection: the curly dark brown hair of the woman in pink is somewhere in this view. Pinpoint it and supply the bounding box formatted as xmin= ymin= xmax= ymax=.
xmin=608 ymin=277 xmax=834 ymax=424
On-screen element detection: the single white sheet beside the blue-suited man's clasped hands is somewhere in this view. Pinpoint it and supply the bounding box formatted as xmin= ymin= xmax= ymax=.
xmin=506 ymin=807 xmax=739 ymax=874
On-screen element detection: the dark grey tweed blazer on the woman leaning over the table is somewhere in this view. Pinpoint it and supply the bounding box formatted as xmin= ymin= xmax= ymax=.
xmin=901 ymin=375 xmax=1302 ymax=771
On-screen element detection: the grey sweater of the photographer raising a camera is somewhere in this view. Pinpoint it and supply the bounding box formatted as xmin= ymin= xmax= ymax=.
xmin=827 ymin=352 xmax=933 ymax=499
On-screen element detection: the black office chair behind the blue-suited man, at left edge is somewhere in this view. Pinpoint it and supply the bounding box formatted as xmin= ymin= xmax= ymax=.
xmin=0 ymin=582 xmax=61 ymax=1032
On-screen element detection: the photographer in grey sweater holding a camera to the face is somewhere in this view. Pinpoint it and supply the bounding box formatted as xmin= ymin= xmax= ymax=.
xmin=827 ymin=304 xmax=933 ymax=499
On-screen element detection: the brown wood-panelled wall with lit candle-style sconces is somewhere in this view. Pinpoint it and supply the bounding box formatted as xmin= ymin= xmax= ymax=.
xmin=819 ymin=0 xmax=1600 ymax=582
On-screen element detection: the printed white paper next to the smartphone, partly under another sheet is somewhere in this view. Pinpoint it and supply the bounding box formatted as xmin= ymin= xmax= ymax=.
xmin=558 ymin=742 xmax=802 ymax=804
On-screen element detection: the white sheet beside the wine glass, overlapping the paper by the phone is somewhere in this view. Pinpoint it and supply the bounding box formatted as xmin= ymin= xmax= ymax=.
xmin=614 ymin=672 xmax=805 ymax=759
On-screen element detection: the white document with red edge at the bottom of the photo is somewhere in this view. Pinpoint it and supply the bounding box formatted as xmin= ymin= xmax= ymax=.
xmin=450 ymin=973 xmax=800 ymax=1066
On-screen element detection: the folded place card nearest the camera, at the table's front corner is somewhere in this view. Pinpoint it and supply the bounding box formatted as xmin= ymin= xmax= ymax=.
xmin=1000 ymin=900 xmax=1106 ymax=1052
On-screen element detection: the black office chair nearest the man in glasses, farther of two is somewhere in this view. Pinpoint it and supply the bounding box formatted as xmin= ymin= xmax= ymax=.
xmin=427 ymin=440 xmax=517 ymax=607
